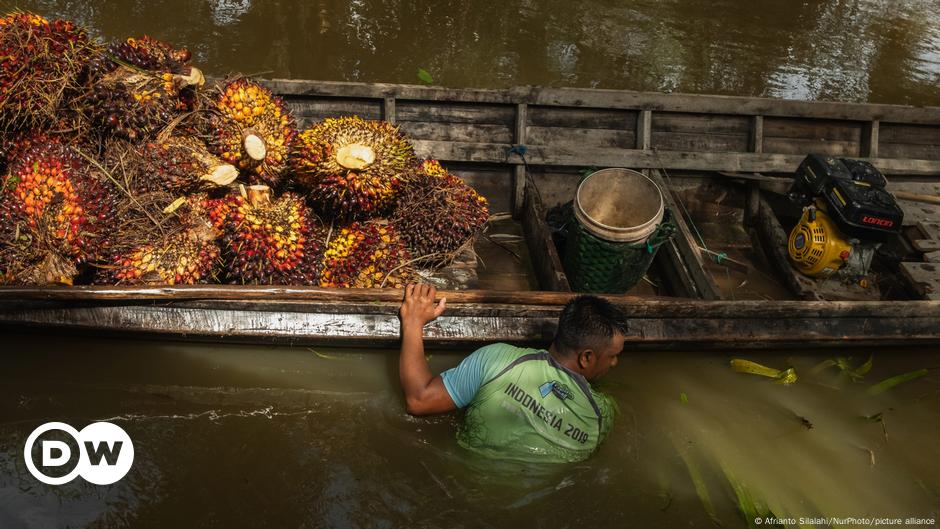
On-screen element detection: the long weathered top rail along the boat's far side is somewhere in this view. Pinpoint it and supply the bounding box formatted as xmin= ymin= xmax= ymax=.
xmin=263 ymin=79 xmax=940 ymax=125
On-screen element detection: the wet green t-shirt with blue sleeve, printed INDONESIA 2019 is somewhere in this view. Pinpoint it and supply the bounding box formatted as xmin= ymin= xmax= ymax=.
xmin=441 ymin=343 xmax=615 ymax=462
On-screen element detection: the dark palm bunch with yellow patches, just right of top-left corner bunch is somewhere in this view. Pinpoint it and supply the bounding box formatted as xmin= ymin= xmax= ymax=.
xmin=82 ymin=66 xmax=188 ymax=141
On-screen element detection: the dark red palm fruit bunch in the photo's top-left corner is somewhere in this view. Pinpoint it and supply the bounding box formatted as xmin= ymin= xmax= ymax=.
xmin=0 ymin=12 xmax=99 ymax=131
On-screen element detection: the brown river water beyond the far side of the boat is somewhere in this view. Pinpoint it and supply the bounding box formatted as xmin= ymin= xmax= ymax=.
xmin=2 ymin=0 xmax=940 ymax=105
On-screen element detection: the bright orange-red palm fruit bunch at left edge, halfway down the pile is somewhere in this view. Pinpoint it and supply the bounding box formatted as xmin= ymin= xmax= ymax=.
xmin=0 ymin=142 xmax=115 ymax=263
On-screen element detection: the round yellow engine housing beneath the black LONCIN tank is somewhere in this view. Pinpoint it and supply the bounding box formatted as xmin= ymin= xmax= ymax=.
xmin=788 ymin=202 xmax=852 ymax=277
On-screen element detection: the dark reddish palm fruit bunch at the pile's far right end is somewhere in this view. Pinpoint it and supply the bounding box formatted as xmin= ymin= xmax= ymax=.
xmin=391 ymin=160 xmax=489 ymax=266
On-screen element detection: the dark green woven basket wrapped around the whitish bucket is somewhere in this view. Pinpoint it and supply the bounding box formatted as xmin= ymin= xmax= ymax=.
xmin=564 ymin=208 xmax=677 ymax=294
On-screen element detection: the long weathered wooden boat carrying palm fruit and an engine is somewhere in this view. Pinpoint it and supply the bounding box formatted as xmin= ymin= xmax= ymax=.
xmin=0 ymin=80 xmax=940 ymax=348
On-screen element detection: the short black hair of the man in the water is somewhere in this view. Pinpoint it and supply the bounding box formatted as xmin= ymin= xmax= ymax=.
xmin=555 ymin=296 xmax=627 ymax=353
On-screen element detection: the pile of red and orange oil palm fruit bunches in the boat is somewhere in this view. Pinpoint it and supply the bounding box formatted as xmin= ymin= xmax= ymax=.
xmin=0 ymin=12 xmax=488 ymax=288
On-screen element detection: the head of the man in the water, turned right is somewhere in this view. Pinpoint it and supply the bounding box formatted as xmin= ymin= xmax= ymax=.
xmin=552 ymin=296 xmax=627 ymax=380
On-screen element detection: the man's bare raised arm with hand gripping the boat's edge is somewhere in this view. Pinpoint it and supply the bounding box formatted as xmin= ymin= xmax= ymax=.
xmin=398 ymin=285 xmax=457 ymax=415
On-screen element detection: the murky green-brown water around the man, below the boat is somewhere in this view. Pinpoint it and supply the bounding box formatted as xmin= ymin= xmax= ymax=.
xmin=0 ymin=336 xmax=940 ymax=529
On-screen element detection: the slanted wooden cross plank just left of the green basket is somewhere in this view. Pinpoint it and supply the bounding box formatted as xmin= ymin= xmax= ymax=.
xmin=522 ymin=180 xmax=571 ymax=292
